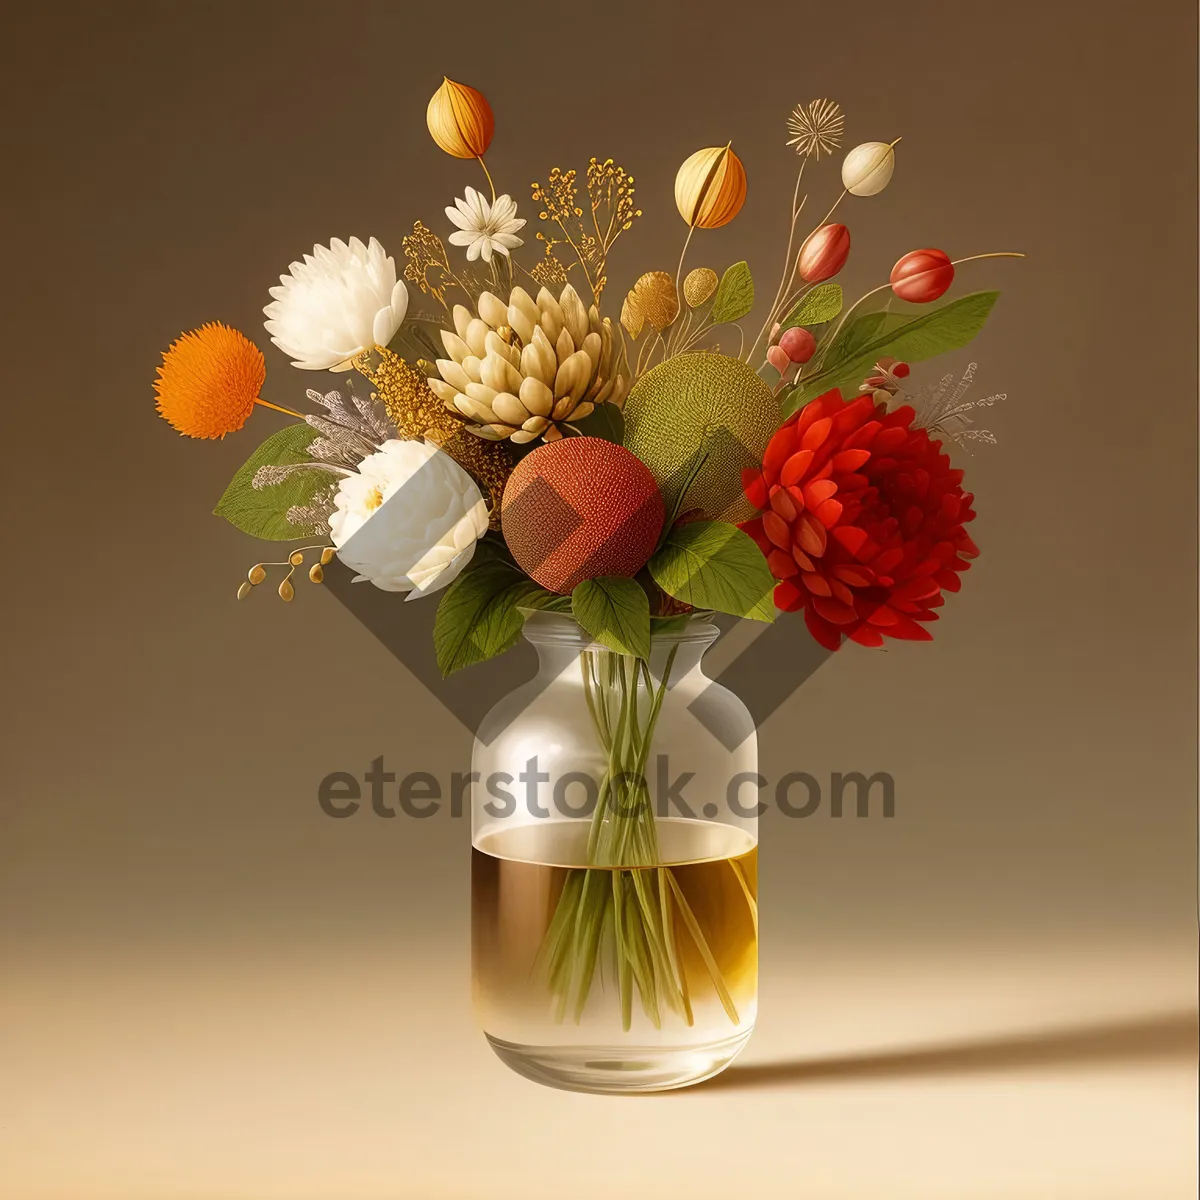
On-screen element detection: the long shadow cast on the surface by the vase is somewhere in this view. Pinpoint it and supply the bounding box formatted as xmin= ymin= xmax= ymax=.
xmin=700 ymin=1009 xmax=1198 ymax=1090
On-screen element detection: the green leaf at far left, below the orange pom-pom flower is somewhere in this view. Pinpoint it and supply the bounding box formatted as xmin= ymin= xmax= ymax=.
xmin=212 ymin=425 xmax=340 ymax=541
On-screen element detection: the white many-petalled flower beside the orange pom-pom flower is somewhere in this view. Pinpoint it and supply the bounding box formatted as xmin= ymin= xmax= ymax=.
xmin=263 ymin=238 xmax=408 ymax=371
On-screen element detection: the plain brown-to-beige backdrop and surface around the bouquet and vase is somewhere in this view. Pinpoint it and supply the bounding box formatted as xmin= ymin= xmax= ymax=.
xmin=0 ymin=0 xmax=1196 ymax=1200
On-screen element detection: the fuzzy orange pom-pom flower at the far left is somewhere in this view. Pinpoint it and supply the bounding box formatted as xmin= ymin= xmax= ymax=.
xmin=154 ymin=322 xmax=270 ymax=438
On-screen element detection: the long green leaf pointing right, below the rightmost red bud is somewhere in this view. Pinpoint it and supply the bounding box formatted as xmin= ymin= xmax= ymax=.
xmin=784 ymin=292 xmax=1000 ymax=415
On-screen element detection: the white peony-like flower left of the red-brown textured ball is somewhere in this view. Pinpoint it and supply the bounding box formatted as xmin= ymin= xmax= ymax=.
xmin=329 ymin=438 xmax=487 ymax=600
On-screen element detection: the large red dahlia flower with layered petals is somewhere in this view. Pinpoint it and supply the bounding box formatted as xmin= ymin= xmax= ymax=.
xmin=742 ymin=390 xmax=979 ymax=650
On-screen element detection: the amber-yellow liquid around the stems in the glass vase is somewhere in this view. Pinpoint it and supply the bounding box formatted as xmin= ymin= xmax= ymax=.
xmin=472 ymin=821 xmax=758 ymax=1046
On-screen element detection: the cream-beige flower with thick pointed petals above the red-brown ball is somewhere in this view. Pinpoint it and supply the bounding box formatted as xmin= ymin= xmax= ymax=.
xmin=430 ymin=284 xmax=629 ymax=442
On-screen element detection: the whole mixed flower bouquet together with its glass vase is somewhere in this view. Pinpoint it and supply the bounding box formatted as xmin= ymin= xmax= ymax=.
xmin=155 ymin=79 xmax=1020 ymax=1091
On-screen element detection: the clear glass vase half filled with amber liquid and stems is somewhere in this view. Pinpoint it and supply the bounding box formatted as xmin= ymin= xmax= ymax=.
xmin=472 ymin=612 xmax=758 ymax=1092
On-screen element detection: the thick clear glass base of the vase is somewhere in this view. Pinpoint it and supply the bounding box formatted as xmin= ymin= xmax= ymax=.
xmin=484 ymin=1026 xmax=754 ymax=1094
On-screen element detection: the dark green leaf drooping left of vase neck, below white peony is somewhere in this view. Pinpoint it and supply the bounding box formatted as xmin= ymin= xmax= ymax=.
xmin=433 ymin=560 xmax=541 ymax=678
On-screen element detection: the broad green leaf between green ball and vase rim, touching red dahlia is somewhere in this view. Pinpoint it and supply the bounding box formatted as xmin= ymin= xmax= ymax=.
xmin=648 ymin=521 xmax=775 ymax=622
